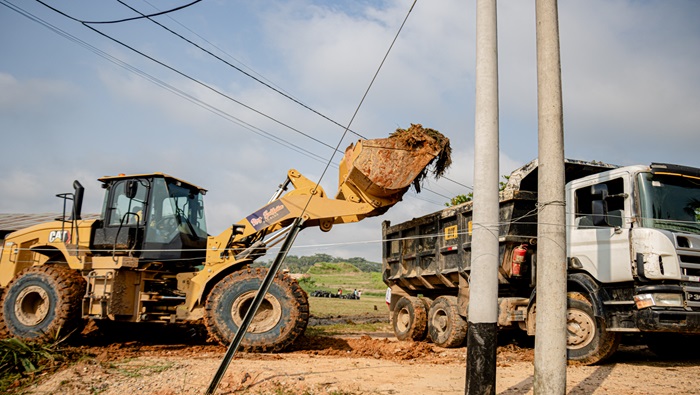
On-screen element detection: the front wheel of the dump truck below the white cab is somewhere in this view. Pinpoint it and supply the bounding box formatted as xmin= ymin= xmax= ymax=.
xmin=566 ymin=298 xmax=620 ymax=365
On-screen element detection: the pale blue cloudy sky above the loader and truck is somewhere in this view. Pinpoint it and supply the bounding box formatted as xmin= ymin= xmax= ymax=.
xmin=0 ymin=0 xmax=700 ymax=261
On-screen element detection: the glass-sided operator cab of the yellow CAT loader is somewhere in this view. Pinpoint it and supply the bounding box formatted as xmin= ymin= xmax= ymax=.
xmin=92 ymin=173 xmax=208 ymax=262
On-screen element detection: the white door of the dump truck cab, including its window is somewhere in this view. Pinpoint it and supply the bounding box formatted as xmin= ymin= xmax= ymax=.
xmin=567 ymin=177 xmax=632 ymax=283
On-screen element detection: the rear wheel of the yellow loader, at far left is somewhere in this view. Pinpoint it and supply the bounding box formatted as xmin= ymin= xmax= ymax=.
xmin=0 ymin=265 xmax=86 ymax=342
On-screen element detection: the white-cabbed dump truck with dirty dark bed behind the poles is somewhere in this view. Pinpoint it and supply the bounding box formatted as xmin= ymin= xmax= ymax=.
xmin=382 ymin=160 xmax=700 ymax=364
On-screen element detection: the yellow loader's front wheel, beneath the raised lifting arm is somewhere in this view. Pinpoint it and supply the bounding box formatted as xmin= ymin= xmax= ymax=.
xmin=204 ymin=268 xmax=309 ymax=352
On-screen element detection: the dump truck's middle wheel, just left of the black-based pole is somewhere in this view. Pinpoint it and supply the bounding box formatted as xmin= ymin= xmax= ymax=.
xmin=428 ymin=296 xmax=467 ymax=348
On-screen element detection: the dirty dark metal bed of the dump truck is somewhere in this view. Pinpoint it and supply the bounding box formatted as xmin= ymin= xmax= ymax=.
xmin=382 ymin=160 xmax=617 ymax=295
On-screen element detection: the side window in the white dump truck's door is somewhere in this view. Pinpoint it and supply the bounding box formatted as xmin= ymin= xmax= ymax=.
xmin=574 ymin=178 xmax=627 ymax=229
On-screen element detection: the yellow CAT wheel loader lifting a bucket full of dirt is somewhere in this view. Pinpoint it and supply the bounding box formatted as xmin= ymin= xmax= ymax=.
xmin=0 ymin=125 xmax=449 ymax=352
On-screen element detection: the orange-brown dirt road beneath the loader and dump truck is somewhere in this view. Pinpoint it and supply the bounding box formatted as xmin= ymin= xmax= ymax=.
xmin=15 ymin=328 xmax=700 ymax=395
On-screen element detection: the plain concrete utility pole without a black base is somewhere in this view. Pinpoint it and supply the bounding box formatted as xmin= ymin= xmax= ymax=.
xmin=534 ymin=0 xmax=567 ymax=394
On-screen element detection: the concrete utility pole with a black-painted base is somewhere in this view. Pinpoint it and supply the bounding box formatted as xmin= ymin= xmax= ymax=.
xmin=465 ymin=0 xmax=499 ymax=395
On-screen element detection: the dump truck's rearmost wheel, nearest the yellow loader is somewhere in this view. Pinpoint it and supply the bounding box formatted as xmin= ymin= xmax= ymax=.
xmin=391 ymin=296 xmax=428 ymax=341
